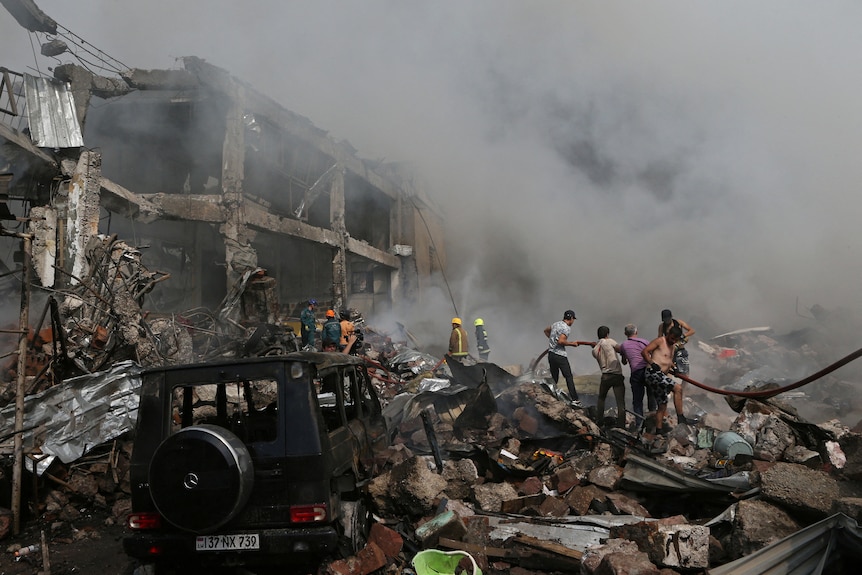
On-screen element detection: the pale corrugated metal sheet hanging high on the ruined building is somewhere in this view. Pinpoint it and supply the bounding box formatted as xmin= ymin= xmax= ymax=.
xmin=24 ymin=74 xmax=84 ymax=148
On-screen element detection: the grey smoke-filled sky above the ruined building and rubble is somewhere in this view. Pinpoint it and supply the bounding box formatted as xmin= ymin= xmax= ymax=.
xmin=5 ymin=0 xmax=862 ymax=372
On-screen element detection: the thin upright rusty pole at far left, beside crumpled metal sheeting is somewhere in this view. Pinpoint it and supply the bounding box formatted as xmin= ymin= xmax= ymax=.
xmin=12 ymin=234 xmax=32 ymax=535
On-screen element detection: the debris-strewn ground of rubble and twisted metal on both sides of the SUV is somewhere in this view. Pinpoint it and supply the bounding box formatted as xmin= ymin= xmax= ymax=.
xmin=0 ymin=238 xmax=862 ymax=575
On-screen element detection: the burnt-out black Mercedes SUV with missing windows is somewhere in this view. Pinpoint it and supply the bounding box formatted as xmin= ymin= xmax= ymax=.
xmin=123 ymin=352 xmax=387 ymax=572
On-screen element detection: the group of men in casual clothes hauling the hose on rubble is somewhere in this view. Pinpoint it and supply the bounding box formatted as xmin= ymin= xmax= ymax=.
xmin=545 ymin=309 xmax=695 ymax=435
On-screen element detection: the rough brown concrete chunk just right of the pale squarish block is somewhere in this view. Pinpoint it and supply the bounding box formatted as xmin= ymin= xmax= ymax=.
xmin=722 ymin=499 xmax=800 ymax=560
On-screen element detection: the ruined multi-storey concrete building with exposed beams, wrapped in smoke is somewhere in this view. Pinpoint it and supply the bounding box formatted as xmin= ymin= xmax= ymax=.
xmin=0 ymin=0 xmax=445 ymax=328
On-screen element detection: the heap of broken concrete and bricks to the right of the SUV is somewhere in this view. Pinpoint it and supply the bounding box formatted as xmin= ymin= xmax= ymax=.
xmin=316 ymin=346 xmax=862 ymax=574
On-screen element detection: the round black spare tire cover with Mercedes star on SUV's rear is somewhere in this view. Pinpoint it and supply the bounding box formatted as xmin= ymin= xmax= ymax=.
xmin=149 ymin=425 xmax=254 ymax=533
